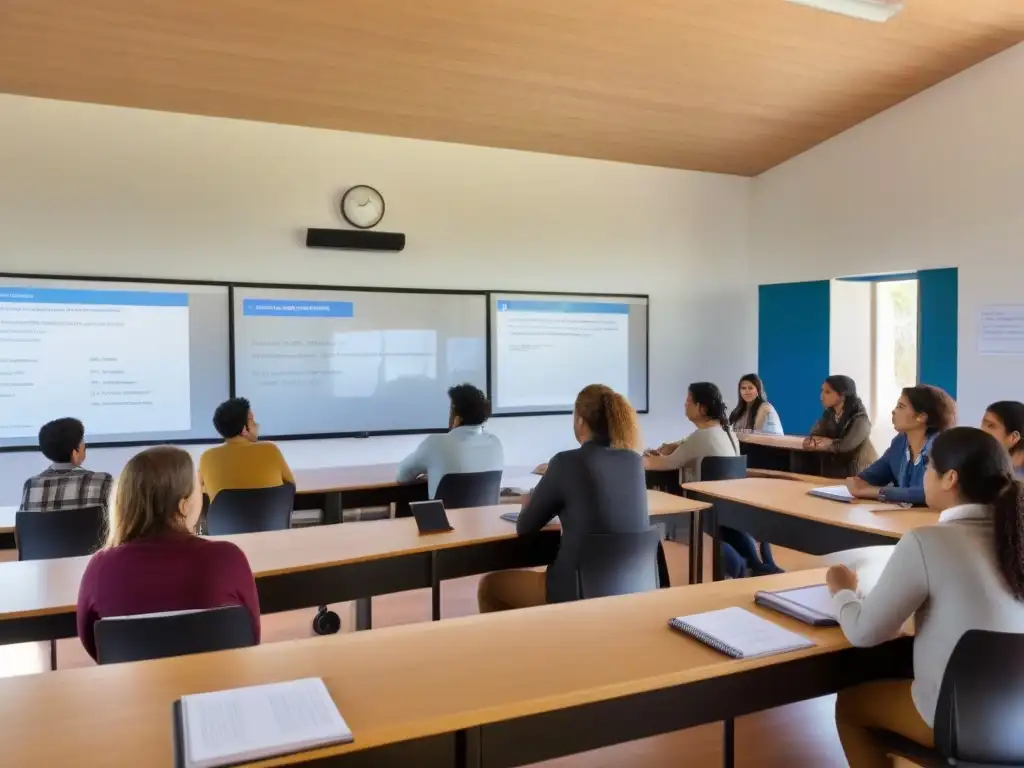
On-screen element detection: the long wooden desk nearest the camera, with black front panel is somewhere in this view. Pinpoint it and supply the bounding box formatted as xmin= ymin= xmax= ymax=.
xmin=0 ymin=570 xmax=909 ymax=768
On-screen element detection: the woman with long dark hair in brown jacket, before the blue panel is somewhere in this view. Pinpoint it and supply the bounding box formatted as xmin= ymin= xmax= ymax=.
xmin=804 ymin=376 xmax=879 ymax=477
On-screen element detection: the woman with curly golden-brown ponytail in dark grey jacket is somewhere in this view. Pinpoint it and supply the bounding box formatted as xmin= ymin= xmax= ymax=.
xmin=477 ymin=384 xmax=650 ymax=613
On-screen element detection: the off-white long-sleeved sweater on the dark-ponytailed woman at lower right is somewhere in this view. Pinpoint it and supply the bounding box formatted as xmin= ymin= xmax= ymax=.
xmin=834 ymin=504 xmax=1024 ymax=725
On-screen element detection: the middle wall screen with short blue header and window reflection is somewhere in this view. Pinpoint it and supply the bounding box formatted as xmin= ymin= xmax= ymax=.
xmin=232 ymin=287 xmax=487 ymax=436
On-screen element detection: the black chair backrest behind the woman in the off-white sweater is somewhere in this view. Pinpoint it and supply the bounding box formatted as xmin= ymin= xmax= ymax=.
xmin=935 ymin=630 xmax=1024 ymax=765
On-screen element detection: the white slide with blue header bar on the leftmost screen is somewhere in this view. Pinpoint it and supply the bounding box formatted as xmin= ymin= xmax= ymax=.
xmin=0 ymin=286 xmax=191 ymax=438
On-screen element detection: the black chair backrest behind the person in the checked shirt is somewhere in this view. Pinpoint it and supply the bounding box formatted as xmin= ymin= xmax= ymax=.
xmin=14 ymin=507 xmax=106 ymax=560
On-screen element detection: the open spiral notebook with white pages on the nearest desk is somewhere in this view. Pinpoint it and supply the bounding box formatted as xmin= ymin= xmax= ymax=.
xmin=669 ymin=605 xmax=814 ymax=658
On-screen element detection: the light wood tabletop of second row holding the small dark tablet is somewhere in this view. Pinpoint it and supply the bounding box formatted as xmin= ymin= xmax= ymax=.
xmin=0 ymin=490 xmax=710 ymax=638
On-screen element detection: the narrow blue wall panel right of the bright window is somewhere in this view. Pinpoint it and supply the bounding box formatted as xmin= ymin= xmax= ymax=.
xmin=918 ymin=267 xmax=959 ymax=397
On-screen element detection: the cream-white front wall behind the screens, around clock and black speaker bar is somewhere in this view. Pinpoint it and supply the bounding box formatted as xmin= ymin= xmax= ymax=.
xmin=0 ymin=95 xmax=756 ymax=504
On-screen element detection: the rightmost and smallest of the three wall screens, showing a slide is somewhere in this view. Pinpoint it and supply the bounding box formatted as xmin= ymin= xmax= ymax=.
xmin=490 ymin=294 xmax=647 ymax=414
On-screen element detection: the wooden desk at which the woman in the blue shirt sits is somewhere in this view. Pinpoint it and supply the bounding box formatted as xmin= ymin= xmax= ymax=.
xmin=683 ymin=477 xmax=939 ymax=581
